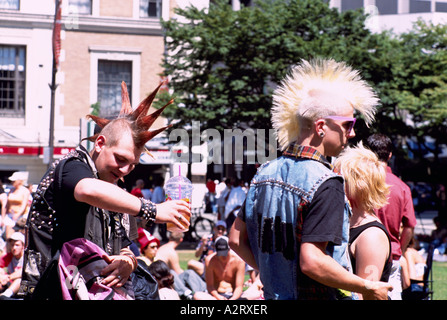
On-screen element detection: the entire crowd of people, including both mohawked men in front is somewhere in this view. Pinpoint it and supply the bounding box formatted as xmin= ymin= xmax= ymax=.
xmin=0 ymin=59 xmax=444 ymax=300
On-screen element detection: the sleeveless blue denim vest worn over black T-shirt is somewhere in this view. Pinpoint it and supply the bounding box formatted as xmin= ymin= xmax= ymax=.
xmin=245 ymin=152 xmax=351 ymax=300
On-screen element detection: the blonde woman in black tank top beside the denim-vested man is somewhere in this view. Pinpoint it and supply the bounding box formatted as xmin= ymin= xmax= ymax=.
xmin=335 ymin=143 xmax=392 ymax=298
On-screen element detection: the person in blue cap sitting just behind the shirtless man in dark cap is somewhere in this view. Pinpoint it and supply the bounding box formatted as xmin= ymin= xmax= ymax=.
xmin=188 ymin=220 xmax=227 ymax=278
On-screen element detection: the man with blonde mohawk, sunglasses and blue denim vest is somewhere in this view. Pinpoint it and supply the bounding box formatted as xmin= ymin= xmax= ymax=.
xmin=230 ymin=59 xmax=391 ymax=300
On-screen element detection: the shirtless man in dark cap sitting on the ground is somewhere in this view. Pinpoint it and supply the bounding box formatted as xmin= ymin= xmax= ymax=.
xmin=205 ymin=236 xmax=245 ymax=300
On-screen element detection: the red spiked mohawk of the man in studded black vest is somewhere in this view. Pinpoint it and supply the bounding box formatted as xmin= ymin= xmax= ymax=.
xmin=83 ymin=81 xmax=174 ymax=152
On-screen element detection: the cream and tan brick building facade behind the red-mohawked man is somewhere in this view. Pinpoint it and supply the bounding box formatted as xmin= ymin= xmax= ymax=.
xmin=0 ymin=0 xmax=212 ymax=188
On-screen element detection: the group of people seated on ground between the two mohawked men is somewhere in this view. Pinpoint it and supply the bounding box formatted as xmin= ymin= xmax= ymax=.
xmin=132 ymin=215 xmax=262 ymax=300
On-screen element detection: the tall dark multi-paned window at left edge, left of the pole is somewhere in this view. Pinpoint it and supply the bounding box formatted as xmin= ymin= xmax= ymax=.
xmin=0 ymin=45 xmax=25 ymax=118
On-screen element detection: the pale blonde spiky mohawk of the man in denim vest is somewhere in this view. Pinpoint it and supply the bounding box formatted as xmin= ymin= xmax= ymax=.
xmin=271 ymin=59 xmax=379 ymax=150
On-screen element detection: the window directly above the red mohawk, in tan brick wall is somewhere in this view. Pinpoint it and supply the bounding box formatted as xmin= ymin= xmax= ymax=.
xmin=98 ymin=60 xmax=132 ymax=118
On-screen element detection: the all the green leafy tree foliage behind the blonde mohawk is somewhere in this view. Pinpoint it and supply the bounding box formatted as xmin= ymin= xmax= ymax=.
xmin=158 ymin=0 xmax=447 ymax=180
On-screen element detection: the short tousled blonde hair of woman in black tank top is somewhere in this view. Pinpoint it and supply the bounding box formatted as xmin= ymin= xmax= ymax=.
xmin=335 ymin=142 xmax=390 ymax=213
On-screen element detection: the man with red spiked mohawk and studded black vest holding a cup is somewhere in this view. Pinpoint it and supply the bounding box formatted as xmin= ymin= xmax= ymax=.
xmin=19 ymin=82 xmax=191 ymax=299
